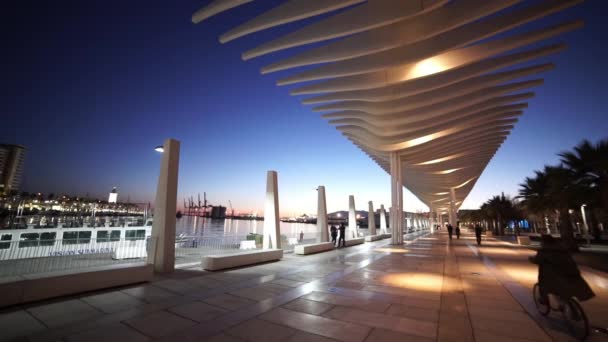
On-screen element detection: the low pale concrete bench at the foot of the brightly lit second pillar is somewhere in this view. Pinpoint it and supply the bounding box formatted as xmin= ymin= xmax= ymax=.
xmin=201 ymin=249 xmax=283 ymax=271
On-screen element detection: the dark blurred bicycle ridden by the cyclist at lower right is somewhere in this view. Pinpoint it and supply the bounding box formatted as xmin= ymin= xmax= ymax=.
xmin=532 ymin=283 xmax=589 ymax=341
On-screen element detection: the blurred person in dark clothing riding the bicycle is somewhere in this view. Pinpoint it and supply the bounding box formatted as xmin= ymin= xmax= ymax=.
xmin=530 ymin=235 xmax=595 ymax=304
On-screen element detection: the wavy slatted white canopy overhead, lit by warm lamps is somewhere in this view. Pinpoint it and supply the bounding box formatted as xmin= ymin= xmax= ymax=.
xmin=192 ymin=0 xmax=583 ymax=212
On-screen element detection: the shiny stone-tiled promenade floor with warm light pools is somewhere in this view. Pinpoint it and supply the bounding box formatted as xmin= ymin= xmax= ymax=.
xmin=0 ymin=232 xmax=608 ymax=342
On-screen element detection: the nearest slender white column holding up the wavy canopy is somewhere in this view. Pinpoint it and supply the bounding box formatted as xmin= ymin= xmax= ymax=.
xmin=390 ymin=152 xmax=404 ymax=245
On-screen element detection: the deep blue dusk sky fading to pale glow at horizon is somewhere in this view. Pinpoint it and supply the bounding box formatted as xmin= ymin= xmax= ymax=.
xmin=0 ymin=0 xmax=608 ymax=215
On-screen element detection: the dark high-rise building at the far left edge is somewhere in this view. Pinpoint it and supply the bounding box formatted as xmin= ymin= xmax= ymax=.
xmin=0 ymin=144 xmax=25 ymax=194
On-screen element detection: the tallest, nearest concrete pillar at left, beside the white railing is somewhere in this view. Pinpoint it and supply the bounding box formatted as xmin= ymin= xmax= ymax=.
xmin=148 ymin=139 xmax=180 ymax=273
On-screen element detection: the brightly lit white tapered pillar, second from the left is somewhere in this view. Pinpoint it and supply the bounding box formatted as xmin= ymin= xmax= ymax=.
xmin=262 ymin=171 xmax=281 ymax=249
